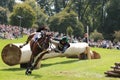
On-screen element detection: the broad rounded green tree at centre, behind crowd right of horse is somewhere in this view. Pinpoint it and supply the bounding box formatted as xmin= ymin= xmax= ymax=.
xmin=49 ymin=11 xmax=83 ymax=35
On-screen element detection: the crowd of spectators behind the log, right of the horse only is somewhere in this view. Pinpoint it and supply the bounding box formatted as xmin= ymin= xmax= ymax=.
xmin=50 ymin=32 xmax=120 ymax=50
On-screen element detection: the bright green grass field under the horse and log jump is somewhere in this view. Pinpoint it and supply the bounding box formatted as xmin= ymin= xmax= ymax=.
xmin=0 ymin=36 xmax=120 ymax=80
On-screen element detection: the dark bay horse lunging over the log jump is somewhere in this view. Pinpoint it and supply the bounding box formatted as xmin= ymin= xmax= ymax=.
xmin=19 ymin=32 xmax=53 ymax=75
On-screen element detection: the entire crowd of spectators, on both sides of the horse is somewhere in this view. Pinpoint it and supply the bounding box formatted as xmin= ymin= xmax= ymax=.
xmin=0 ymin=25 xmax=120 ymax=50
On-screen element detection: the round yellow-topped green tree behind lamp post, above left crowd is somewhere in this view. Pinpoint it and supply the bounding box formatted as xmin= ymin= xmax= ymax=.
xmin=10 ymin=3 xmax=36 ymax=27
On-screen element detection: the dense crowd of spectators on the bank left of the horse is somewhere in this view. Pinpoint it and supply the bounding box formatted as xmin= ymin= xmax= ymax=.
xmin=0 ymin=24 xmax=35 ymax=39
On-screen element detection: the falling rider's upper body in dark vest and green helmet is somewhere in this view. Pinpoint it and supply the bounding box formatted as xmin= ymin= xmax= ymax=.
xmin=55 ymin=36 xmax=70 ymax=53
